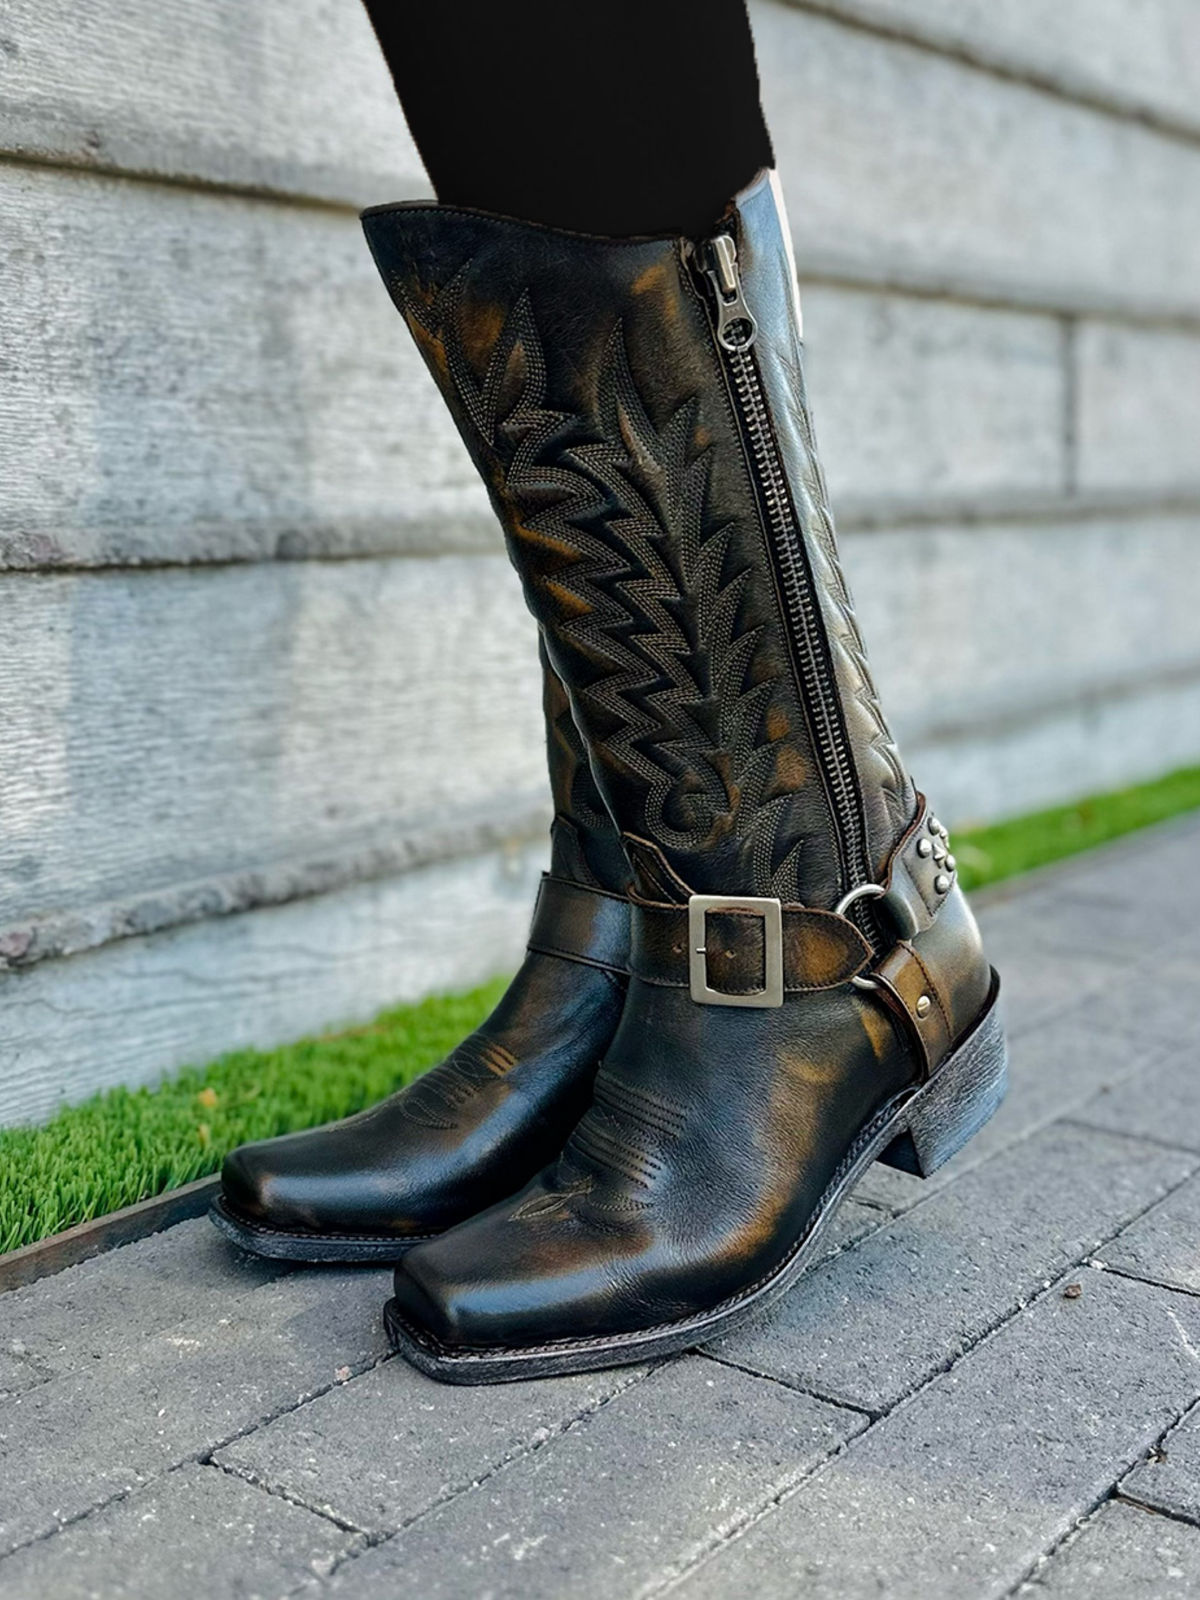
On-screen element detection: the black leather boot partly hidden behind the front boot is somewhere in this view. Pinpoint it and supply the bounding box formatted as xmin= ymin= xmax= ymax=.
xmin=211 ymin=651 xmax=629 ymax=1261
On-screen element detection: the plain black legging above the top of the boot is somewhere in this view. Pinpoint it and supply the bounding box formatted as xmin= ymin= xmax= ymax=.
xmin=365 ymin=0 xmax=771 ymax=235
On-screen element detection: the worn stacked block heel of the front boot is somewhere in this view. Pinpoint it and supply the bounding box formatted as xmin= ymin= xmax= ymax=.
xmin=878 ymin=994 xmax=1008 ymax=1178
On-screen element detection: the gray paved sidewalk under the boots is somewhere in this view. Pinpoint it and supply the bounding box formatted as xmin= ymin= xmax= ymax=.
xmin=0 ymin=822 xmax=1200 ymax=1600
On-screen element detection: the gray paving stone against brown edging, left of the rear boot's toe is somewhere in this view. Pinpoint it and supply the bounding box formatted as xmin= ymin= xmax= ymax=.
xmin=0 ymin=1218 xmax=291 ymax=1369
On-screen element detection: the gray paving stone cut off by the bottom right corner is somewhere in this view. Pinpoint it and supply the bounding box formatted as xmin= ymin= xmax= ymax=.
xmin=1021 ymin=1501 xmax=1200 ymax=1600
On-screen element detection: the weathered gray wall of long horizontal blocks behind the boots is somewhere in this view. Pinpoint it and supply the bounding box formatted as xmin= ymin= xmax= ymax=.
xmin=0 ymin=0 xmax=1200 ymax=1125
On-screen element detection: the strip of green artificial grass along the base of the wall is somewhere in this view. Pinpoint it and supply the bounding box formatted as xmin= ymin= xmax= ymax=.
xmin=0 ymin=766 xmax=1200 ymax=1253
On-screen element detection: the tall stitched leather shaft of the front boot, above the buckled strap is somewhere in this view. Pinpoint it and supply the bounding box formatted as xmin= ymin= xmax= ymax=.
xmin=365 ymin=174 xmax=915 ymax=907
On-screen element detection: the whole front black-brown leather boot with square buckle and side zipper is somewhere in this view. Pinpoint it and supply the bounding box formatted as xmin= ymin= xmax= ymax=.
xmin=365 ymin=174 xmax=1005 ymax=1382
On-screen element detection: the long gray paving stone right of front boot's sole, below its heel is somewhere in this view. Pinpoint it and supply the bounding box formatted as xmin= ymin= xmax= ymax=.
xmin=714 ymin=1125 xmax=1200 ymax=1413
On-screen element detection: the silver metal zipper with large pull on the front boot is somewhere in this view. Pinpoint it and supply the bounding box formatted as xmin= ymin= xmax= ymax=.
xmin=699 ymin=234 xmax=875 ymax=921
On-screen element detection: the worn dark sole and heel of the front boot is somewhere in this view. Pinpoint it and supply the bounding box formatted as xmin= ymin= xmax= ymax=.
xmin=384 ymin=973 xmax=1008 ymax=1384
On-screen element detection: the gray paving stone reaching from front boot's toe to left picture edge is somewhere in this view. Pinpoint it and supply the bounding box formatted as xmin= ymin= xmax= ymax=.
xmin=0 ymin=1272 xmax=390 ymax=1554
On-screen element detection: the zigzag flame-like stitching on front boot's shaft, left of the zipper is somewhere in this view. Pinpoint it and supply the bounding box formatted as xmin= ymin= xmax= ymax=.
xmin=400 ymin=272 xmax=803 ymax=901
